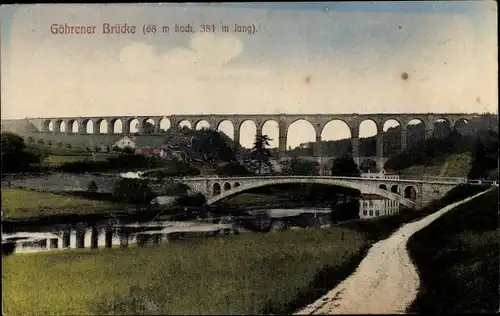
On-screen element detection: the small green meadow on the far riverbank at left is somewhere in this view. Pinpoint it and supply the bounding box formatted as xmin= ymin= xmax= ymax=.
xmin=2 ymin=188 xmax=123 ymax=220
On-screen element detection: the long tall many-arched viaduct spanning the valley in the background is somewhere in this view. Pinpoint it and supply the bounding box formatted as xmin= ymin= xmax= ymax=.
xmin=12 ymin=113 xmax=488 ymax=169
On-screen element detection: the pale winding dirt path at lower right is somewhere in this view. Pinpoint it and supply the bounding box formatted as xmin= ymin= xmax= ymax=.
xmin=296 ymin=192 xmax=486 ymax=315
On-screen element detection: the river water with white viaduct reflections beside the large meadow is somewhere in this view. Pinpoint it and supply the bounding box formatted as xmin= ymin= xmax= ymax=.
xmin=2 ymin=209 xmax=331 ymax=255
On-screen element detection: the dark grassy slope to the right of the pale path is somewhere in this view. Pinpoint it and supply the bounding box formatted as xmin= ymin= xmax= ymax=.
xmin=408 ymin=188 xmax=500 ymax=314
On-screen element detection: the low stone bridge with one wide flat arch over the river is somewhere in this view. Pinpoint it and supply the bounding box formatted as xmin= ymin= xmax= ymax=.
xmin=167 ymin=176 xmax=461 ymax=209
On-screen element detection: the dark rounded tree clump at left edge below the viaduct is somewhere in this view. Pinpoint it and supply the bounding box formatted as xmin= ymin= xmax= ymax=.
xmin=1 ymin=132 xmax=43 ymax=173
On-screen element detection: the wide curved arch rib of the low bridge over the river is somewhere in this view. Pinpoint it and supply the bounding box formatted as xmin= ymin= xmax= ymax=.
xmin=206 ymin=177 xmax=416 ymax=208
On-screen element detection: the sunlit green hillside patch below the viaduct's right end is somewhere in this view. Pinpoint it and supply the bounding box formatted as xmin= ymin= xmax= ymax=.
xmin=400 ymin=153 xmax=472 ymax=178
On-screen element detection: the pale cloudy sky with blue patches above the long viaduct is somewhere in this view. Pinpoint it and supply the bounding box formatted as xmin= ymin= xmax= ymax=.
xmin=0 ymin=0 xmax=498 ymax=147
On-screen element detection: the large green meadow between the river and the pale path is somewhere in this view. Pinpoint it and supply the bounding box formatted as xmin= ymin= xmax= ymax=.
xmin=2 ymin=228 xmax=368 ymax=315
